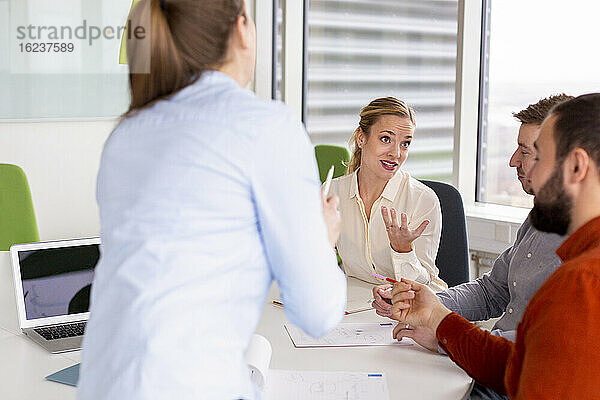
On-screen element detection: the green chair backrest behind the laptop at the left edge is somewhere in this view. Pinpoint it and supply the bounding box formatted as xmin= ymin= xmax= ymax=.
xmin=0 ymin=164 xmax=40 ymax=251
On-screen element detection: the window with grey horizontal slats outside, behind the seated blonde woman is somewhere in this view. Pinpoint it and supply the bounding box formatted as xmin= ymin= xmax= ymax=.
xmin=303 ymin=0 xmax=458 ymax=182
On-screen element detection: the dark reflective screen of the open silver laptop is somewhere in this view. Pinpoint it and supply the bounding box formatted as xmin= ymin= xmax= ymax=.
xmin=19 ymin=244 xmax=100 ymax=320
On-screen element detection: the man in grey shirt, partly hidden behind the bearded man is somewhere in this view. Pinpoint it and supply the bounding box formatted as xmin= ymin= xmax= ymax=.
xmin=373 ymin=94 xmax=572 ymax=399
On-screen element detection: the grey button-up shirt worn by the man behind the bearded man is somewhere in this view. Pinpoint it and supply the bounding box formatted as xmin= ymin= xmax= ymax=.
xmin=437 ymin=217 xmax=565 ymax=342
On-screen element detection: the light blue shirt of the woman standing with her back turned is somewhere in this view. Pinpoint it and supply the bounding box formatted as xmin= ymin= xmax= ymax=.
xmin=78 ymin=72 xmax=346 ymax=400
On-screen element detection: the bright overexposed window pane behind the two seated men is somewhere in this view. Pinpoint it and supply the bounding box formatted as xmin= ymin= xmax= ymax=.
xmin=477 ymin=0 xmax=600 ymax=207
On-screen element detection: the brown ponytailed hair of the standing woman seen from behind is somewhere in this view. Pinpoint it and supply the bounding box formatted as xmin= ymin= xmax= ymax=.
xmin=124 ymin=0 xmax=245 ymax=117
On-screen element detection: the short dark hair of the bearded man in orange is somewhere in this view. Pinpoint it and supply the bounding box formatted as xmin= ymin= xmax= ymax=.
xmin=550 ymin=93 xmax=600 ymax=168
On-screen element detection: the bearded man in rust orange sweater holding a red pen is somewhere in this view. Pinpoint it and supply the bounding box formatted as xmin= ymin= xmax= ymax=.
xmin=392 ymin=94 xmax=600 ymax=399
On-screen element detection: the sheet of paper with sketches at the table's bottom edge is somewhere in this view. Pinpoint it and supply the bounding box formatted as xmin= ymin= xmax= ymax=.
xmin=265 ymin=370 xmax=390 ymax=400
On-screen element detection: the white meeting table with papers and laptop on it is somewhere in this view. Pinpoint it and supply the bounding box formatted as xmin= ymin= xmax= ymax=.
xmin=0 ymin=252 xmax=471 ymax=400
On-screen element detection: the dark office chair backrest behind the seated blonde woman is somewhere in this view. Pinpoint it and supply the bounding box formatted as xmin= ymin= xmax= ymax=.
xmin=421 ymin=181 xmax=469 ymax=287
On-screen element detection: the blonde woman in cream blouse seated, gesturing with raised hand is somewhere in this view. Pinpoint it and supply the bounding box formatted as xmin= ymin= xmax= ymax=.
xmin=331 ymin=97 xmax=448 ymax=299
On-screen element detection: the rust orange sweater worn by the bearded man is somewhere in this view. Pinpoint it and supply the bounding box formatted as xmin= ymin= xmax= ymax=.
xmin=436 ymin=217 xmax=600 ymax=399
